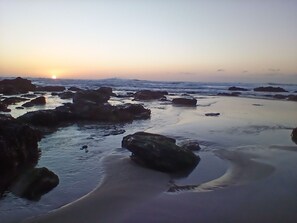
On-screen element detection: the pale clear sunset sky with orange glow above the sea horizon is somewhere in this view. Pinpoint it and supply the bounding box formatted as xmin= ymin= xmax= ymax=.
xmin=0 ymin=0 xmax=297 ymax=83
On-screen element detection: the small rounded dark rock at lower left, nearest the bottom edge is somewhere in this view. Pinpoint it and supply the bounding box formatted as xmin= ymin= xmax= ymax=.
xmin=11 ymin=167 xmax=59 ymax=201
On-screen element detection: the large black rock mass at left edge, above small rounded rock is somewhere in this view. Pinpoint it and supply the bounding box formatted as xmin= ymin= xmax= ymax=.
xmin=0 ymin=114 xmax=41 ymax=195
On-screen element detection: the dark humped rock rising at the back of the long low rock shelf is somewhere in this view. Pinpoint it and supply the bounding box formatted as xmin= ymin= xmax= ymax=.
xmin=73 ymin=90 xmax=110 ymax=105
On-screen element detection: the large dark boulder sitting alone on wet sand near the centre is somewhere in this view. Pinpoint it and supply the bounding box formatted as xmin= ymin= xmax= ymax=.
xmin=122 ymin=132 xmax=200 ymax=173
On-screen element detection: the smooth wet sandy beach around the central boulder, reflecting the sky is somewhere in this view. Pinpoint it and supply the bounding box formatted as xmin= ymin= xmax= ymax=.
xmin=17 ymin=97 xmax=297 ymax=223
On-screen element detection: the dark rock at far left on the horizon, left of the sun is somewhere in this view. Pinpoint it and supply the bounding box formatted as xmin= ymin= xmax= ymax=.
xmin=0 ymin=77 xmax=36 ymax=95
